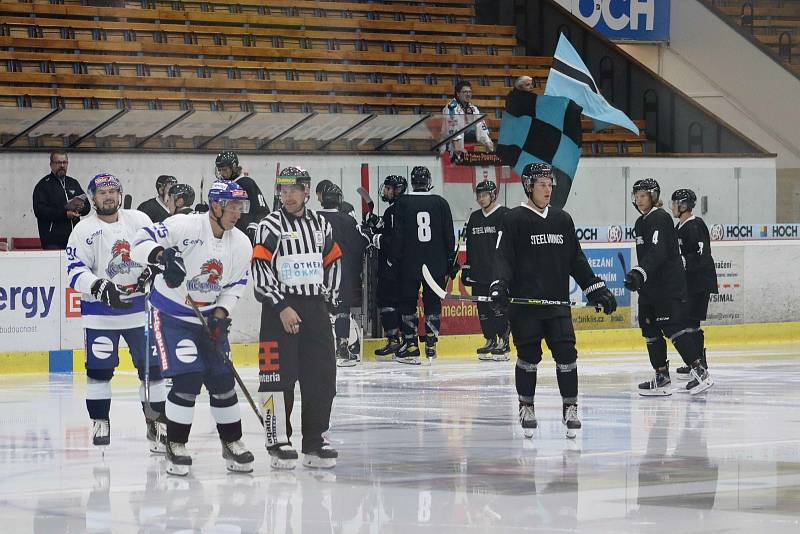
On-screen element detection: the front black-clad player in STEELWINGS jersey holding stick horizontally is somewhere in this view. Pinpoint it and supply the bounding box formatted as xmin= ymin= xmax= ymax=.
xmin=489 ymin=163 xmax=617 ymax=438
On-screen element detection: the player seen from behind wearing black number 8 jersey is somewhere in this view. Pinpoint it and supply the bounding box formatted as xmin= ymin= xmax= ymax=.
xmin=391 ymin=167 xmax=460 ymax=365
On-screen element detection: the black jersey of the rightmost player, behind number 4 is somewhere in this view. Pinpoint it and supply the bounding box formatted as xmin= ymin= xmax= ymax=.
xmin=675 ymin=215 xmax=718 ymax=293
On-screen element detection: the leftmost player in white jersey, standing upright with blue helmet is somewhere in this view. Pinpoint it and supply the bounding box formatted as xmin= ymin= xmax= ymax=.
xmin=66 ymin=173 xmax=166 ymax=453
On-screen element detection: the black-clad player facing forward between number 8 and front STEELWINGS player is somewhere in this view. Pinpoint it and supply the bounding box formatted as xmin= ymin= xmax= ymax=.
xmin=461 ymin=180 xmax=510 ymax=361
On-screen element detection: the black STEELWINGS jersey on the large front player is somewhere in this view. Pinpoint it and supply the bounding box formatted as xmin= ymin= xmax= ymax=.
xmin=494 ymin=204 xmax=600 ymax=318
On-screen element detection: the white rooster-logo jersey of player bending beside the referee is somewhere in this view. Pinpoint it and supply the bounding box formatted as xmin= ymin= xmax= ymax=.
xmin=132 ymin=213 xmax=253 ymax=324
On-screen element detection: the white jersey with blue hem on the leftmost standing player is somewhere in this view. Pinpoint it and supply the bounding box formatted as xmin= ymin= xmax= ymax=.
xmin=66 ymin=209 xmax=152 ymax=330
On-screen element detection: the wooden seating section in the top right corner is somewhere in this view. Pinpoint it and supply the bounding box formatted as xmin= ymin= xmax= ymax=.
xmin=707 ymin=0 xmax=800 ymax=76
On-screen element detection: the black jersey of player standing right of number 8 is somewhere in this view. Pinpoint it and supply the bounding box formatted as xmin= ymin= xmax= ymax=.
xmin=467 ymin=206 xmax=511 ymax=285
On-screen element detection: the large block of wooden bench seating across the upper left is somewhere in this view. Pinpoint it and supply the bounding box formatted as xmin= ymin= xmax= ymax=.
xmin=0 ymin=0 xmax=646 ymax=153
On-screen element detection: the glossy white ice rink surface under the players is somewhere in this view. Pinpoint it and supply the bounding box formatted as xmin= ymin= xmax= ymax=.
xmin=0 ymin=345 xmax=800 ymax=534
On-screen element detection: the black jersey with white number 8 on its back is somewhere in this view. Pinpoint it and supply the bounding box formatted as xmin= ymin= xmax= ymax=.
xmin=391 ymin=191 xmax=456 ymax=279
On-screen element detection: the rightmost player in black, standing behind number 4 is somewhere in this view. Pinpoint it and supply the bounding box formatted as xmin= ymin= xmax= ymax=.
xmin=672 ymin=189 xmax=718 ymax=386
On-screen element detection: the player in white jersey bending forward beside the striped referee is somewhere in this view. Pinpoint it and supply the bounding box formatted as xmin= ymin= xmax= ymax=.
xmin=133 ymin=181 xmax=253 ymax=476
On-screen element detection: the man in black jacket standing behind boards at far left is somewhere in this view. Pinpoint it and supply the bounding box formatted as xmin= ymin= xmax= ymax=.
xmin=33 ymin=150 xmax=89 ymax=250
